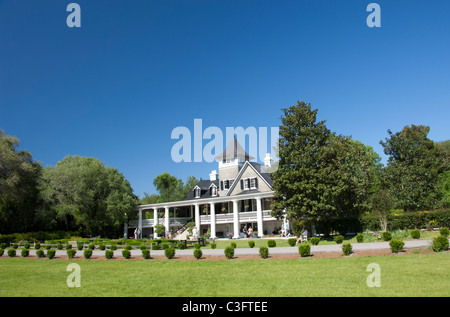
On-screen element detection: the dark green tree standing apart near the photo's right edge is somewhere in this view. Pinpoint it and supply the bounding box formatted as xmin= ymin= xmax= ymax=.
xmin=380 ymin=125 xmax=445 ymax=211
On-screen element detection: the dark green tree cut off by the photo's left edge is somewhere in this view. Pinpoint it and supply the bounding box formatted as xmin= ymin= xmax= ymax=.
xmin=0 ymin=129 xmax=42 ymax=233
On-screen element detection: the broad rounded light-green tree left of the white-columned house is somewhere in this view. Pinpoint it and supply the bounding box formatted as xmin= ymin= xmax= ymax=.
xmin=40 ymin=156 xmax=138 ymax=236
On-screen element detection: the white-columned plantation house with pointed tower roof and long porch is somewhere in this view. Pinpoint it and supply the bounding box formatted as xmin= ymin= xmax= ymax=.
xmin=125 ymin=137 xmax=285 ymax=239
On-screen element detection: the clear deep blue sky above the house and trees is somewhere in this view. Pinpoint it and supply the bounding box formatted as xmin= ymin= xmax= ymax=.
xmin=0 ymin=0 xmax=450 ymax=197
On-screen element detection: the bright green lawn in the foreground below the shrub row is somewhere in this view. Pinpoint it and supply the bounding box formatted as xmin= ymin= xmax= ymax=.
xmin=0 ymin=252 xmax=450 ymax=297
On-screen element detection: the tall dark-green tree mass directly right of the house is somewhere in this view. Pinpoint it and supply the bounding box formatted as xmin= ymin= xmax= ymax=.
xmin=271 ymin=102 xmax=380 ymax=232
